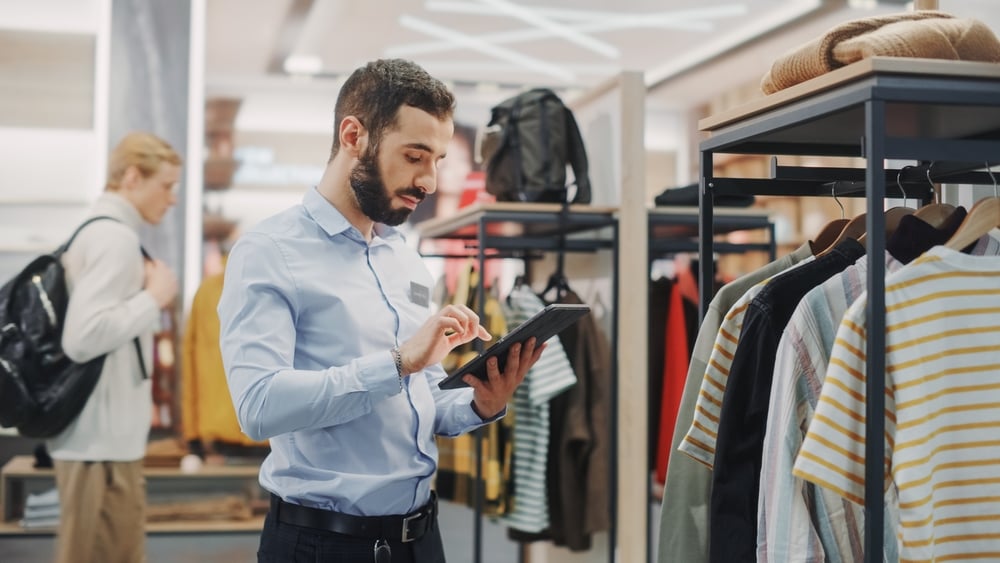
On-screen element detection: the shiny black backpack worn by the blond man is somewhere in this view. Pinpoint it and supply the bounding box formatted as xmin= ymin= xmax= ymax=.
xmin=0 ymin=216 xmax=148 ymax=438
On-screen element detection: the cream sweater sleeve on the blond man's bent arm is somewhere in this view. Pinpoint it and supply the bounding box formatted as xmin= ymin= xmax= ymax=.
xmin=62 ymin=221 xmax=160 ymax=363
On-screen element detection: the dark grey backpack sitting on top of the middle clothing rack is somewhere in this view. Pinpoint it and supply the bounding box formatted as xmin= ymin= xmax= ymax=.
xmin=480 ymin=88 xmax=590 ymax=207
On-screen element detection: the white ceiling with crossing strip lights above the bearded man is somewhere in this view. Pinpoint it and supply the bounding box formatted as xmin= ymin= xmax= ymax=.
xmin=206 ymin=0 xmax=1000 ymax=128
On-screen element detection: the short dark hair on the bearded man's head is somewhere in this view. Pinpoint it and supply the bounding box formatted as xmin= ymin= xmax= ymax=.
xmin=330 ymin=59 xmax=455 ymax=160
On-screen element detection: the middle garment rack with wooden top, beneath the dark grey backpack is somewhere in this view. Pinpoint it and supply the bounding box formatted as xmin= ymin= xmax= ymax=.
xmin=419 ymin=203 xmax=618 ymax=563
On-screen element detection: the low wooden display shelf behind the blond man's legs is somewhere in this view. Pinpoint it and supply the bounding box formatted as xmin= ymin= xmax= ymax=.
xmin=0 ymin=456 xmax=264 ymax=535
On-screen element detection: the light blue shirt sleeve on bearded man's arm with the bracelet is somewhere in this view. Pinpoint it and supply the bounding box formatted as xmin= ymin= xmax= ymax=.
xmin=218 ymin=233 xmax=402 ymax=440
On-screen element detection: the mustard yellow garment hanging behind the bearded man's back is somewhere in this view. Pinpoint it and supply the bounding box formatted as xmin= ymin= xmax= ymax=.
xmin=181 ymin=274 xmax=267 ymax=446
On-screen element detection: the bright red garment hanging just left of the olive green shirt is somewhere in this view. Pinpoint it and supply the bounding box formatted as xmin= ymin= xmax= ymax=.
xmin=656 ymin=284 xmax=690 ymax=485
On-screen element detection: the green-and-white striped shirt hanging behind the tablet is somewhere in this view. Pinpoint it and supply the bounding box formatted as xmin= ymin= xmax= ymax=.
xmin=503 ymin=286 xmax=576 ymax=533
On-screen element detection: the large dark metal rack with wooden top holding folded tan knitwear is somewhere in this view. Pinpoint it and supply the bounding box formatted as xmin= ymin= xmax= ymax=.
xmin=699 ymin=58 xmax=1000 ymax=562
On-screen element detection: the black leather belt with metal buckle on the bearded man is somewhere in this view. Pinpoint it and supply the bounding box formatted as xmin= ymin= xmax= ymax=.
xmin=271 ymin=492 xmax=437 ymax=542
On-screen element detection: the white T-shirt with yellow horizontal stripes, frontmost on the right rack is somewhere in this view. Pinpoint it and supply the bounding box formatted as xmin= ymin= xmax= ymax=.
xmin=794 ymin=241 xmax=1000 ymax=562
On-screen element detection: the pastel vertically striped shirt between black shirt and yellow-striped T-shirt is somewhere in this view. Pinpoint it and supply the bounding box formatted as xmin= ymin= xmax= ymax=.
xmin=757 ymin=252 xmax=903 ymax=563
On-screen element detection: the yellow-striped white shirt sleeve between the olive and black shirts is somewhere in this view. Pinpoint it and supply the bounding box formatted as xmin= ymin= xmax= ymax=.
xmin=677 ymin=256 xmax=815 ymax=468
